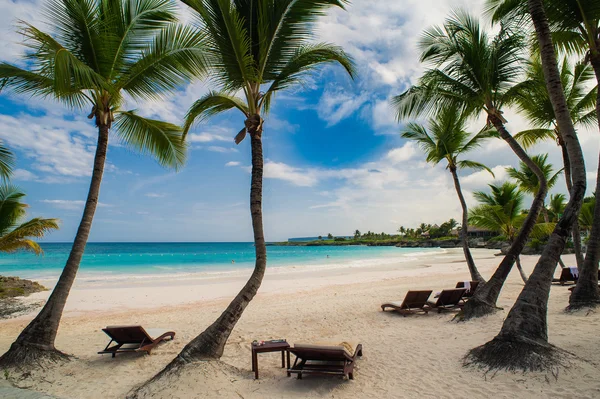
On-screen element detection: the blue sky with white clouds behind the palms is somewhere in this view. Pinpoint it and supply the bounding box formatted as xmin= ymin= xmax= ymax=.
xmin=0 ymin=0 xmax=600 ymax=241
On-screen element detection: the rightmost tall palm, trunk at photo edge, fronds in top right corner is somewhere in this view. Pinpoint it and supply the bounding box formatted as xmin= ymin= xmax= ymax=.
xmin=491 ymin=0 xmax=600 ymax=309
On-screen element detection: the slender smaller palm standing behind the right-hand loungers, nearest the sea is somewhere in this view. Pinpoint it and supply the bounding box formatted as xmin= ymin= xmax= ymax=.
xmin=402 ymin=107 xmax=495 ymax=282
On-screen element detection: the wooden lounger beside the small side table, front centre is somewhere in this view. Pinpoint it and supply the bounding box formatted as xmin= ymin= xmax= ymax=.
xmin=287 ymin=342 xmax=362 ymax=380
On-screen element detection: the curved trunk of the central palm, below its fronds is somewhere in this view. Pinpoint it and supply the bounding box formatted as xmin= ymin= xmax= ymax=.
xmin=134 ymin=122 xmax=267 ymax=390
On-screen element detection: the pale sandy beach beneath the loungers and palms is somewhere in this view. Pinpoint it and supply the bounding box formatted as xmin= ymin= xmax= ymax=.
xmin=0 ymin=249 xmax=600 ymax=399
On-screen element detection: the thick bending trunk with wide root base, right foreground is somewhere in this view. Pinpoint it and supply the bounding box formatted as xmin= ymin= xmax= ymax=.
xmin=465 ymin=0 xmax=586 ymax=371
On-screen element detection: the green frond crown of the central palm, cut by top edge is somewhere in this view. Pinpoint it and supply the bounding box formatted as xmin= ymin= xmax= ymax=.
xmin=183 ymin=0 xmax=354 ymax=138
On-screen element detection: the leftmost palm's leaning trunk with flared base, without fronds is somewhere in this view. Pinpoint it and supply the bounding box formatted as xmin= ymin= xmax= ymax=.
xmin=0 ymin=125 xmax=108 ymax=366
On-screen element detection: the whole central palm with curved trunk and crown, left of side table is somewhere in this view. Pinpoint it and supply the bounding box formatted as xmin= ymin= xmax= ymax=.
xmin=134 ymin=0 xmax=354 ymax=386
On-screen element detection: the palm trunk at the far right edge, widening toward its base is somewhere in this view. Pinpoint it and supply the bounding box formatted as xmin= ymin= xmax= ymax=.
xmin=567 ymin=52 xmax=600 ymax=309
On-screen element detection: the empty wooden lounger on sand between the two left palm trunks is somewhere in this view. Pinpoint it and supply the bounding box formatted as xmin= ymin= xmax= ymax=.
xmin=98 ymin=326 xmax=175 ymax=357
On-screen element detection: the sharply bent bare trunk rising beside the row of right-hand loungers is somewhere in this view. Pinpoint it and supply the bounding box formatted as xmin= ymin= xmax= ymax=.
xmin=460 ymin=115 xmax=548 ymax=321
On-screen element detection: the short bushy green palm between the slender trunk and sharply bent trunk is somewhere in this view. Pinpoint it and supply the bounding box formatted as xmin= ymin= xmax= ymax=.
xmin=468 ymin=182 xmax=535 ymax=282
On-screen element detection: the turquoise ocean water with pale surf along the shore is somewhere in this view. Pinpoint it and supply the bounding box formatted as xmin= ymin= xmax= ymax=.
xmin=0 ymin=242 xmax=444 ymax=280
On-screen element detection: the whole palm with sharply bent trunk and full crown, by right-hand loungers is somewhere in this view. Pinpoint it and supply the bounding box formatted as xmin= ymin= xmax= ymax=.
xmin=394 ymin=11 xmax=547 ymax=320
